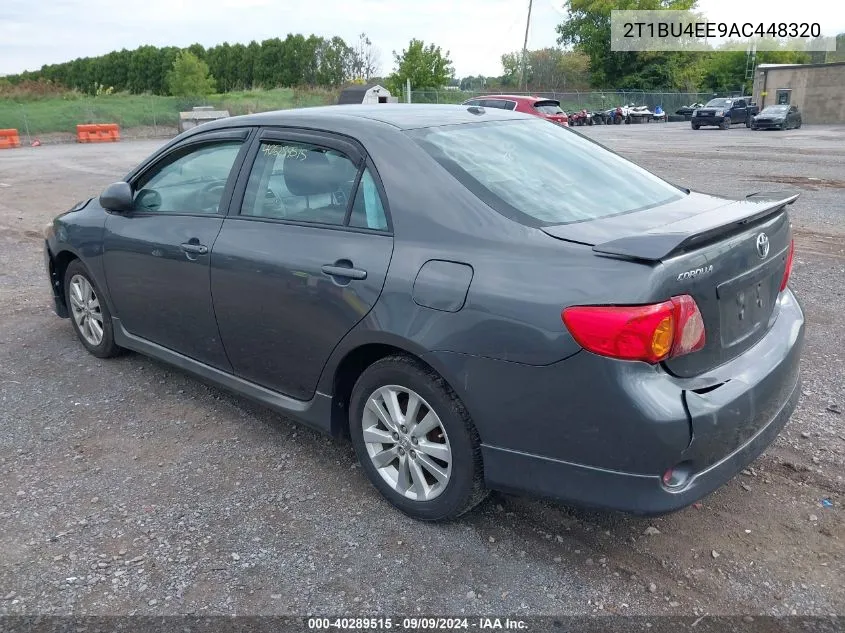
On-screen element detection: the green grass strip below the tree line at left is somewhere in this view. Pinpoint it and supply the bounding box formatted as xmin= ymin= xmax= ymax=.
xmin=0 ymin=88 xmax=337 ymax=135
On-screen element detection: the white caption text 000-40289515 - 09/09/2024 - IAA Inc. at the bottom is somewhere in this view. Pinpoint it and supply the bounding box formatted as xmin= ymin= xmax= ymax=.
xmin=308 ymin=617 xmax=528 ymax=631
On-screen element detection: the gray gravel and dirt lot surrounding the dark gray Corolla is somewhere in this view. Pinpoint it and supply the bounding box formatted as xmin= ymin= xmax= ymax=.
xmin=0 ymin=124 xmax=845 ymax=615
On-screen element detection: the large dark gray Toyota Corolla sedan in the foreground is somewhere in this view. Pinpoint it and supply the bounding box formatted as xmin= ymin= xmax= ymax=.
xmin=44 ymin=104 xmax=804 ymax=520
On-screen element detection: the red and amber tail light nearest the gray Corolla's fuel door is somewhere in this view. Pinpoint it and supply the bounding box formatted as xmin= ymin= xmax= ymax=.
xmin=561 ymin=295 xmax=705 ymax=363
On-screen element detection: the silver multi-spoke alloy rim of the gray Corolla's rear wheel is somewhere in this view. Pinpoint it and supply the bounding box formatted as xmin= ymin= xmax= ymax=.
xmin=361 ymin=385 xmax=452 ymax=501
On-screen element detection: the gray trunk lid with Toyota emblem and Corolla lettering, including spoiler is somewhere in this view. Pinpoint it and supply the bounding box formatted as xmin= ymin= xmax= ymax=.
xmin=542 ymin=192 xmax=798 ymax=377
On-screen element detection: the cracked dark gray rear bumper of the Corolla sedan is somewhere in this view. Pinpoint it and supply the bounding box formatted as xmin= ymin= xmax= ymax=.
xmin=432 ymin=291 xmax=804 ymax=514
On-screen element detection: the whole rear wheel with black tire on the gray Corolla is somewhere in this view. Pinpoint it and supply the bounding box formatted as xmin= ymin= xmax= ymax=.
xmin=349 ymin=356 xmax=487 ymax=521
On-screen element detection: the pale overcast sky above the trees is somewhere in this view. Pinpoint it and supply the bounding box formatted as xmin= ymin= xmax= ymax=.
xmin=0 ymin=0 xmax=845 ymax=77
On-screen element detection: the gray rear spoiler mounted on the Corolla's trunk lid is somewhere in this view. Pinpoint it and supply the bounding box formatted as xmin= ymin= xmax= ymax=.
xmin=593 ymin=191 xmax=801 ymax=261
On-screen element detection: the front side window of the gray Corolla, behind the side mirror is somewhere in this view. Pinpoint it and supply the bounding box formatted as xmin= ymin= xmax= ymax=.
xmin=133 ymin=141 xmax=242 ymax=214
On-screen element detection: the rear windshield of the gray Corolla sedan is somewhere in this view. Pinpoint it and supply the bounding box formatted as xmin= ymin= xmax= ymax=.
xmin=409 ymin=119 xmax=684 ymax=226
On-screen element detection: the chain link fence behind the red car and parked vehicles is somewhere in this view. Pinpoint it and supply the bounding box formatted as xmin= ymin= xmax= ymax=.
xmin=403 ymin=90 xmax=715 ymax=114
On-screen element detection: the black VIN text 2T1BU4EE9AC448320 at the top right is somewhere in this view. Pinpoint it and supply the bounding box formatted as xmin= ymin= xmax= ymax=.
xmin=623 ymin=22 xmax=822 ymax=39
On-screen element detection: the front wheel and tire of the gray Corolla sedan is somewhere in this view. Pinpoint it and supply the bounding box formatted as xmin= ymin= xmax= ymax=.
xmin=64 ymin=259 xmax=123 ymax=358
